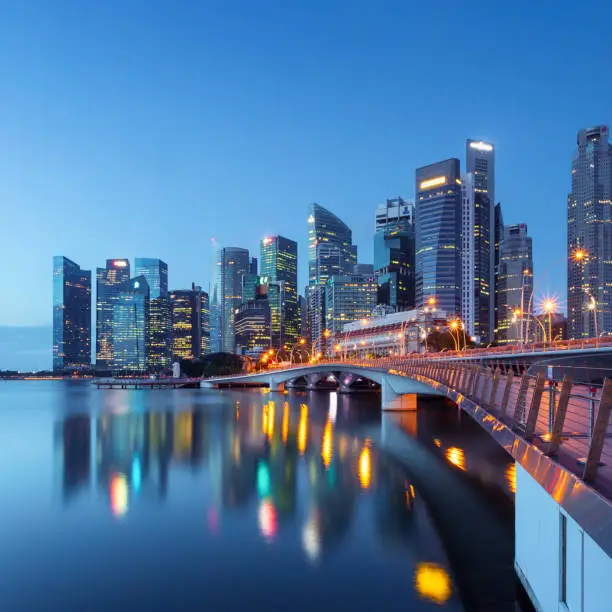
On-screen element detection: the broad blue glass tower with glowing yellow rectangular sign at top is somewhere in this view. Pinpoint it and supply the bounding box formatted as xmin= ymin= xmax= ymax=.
xmin=415 ymin=159 xmax=461 ymax=316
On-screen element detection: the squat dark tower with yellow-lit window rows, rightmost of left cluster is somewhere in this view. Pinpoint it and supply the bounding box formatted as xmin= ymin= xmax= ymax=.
xmin=170 ymin=283 xmax=210 ymax=360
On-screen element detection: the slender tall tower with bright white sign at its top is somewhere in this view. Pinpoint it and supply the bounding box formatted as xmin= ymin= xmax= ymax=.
xmin=461 ymin=140 xmax=495 ymax=343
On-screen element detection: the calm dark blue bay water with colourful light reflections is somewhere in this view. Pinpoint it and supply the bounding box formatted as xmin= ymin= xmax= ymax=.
xmin=0 ymin=381 xmax=514 ymax=612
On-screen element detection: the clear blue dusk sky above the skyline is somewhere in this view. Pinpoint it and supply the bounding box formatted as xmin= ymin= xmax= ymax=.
xmin=0 ymin=0 xmax=612 ymax=358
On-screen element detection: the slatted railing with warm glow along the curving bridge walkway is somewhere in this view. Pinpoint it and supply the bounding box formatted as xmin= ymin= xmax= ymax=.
xmin=367 ymin=359 xmax=612 ymax=492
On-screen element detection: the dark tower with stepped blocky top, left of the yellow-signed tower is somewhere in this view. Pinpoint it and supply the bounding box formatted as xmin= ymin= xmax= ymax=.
xmin=374 ymin=198 xmax=415 ymax=311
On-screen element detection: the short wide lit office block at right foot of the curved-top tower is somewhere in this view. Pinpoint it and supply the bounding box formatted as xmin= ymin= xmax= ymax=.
xmin=325 ymin=274 xmax=378 ymax=334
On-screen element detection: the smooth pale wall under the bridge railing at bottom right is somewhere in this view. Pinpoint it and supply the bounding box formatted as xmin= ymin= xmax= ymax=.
xmin=515 ymin=464 xmax=612 ymax=612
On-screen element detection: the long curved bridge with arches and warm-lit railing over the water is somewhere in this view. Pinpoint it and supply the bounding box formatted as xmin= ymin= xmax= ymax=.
xmin=202 ymin=354 xmax=612 ymax=612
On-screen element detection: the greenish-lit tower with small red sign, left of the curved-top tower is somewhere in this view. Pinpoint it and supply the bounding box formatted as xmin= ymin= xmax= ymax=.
xmin=259 ymin=236 xmax=299 ymax=348
